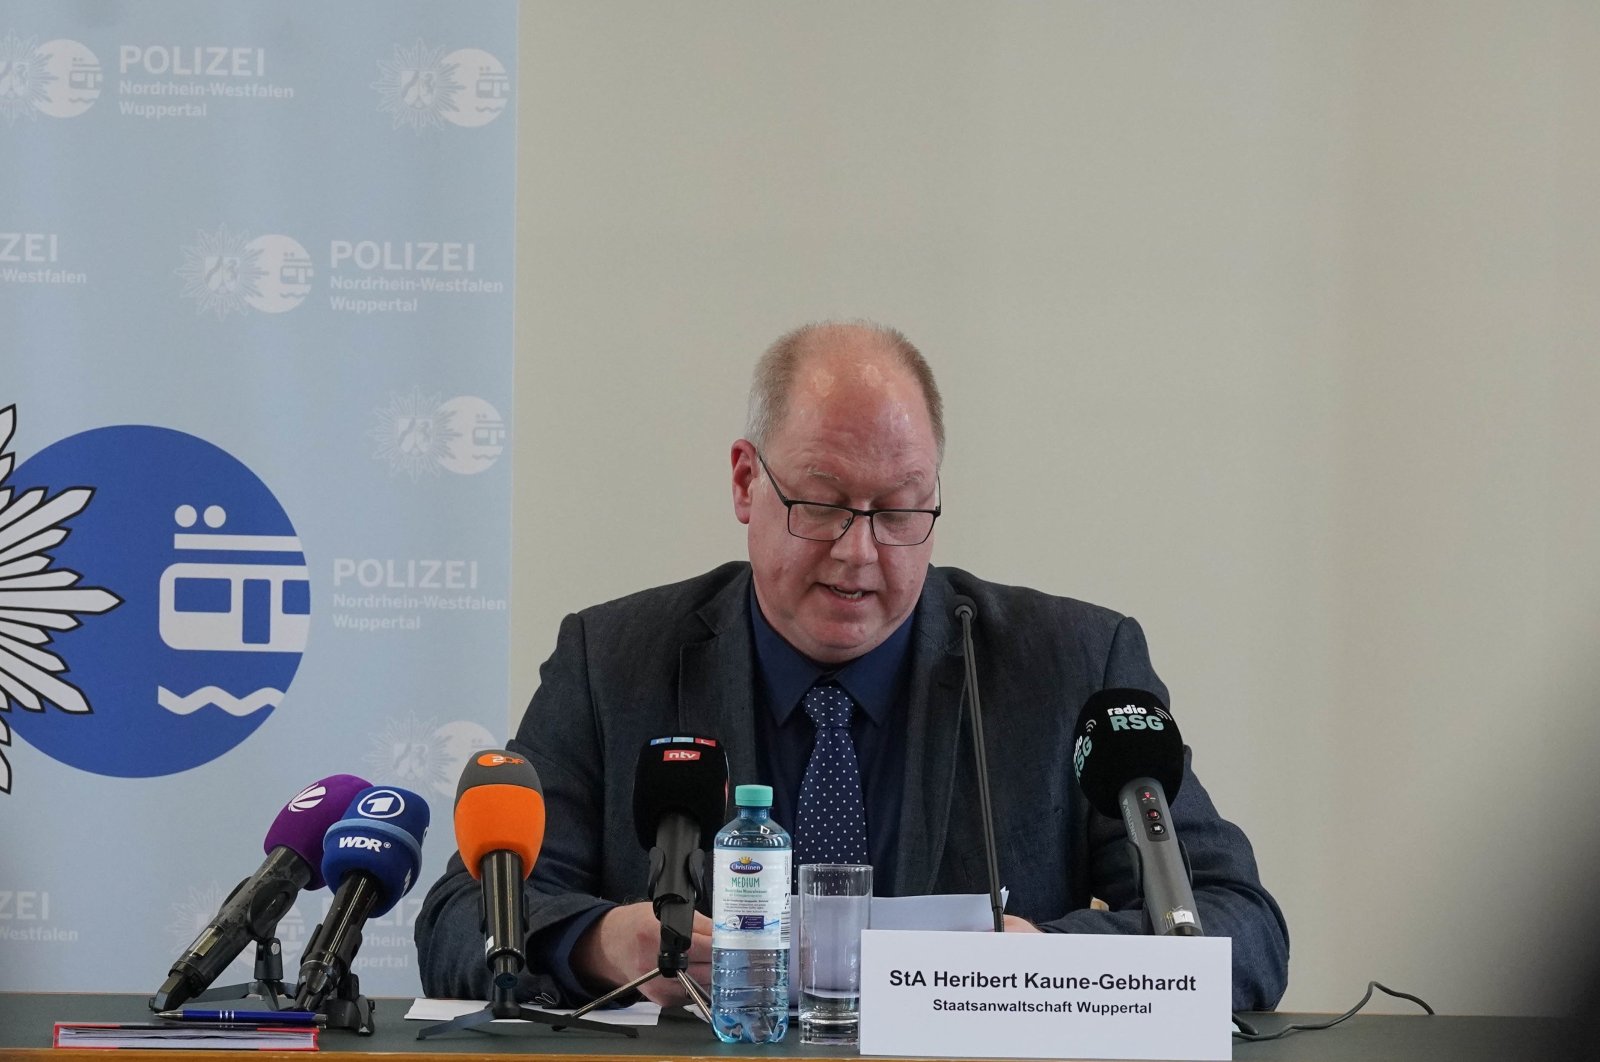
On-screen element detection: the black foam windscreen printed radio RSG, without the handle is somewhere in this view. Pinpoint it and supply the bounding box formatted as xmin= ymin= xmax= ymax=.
xmin=1072 ymin=689 xmax=1184 ymax=819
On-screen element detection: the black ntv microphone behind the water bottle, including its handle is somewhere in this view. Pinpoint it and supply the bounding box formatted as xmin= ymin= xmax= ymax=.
xmin=634 ymin=737 xmax=728 ymax=976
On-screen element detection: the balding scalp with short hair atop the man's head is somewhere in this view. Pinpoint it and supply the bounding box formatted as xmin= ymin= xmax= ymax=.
xmin=744 ymin=321 xmax=944 ymax=462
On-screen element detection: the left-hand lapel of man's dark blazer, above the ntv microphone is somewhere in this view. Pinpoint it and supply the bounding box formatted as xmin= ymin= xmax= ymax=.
xmin=678 ymin=573 xmax=757 ymax=797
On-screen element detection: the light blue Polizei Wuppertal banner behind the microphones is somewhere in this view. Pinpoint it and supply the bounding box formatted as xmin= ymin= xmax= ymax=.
xmin=0 ymin=0 xmax=517 ymax=995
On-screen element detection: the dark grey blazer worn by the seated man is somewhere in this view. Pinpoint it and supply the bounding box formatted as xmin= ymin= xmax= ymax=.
xmin=416 ymin=561 xmax=1288 ymax=1011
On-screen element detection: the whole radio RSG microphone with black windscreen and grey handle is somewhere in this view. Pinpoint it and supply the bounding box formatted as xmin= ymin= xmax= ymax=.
xmin=1072 ymin=689 xmax=1205 ymax=937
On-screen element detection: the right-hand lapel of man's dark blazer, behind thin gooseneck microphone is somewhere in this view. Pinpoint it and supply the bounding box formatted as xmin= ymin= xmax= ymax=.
xmin=893 ymin=568 xmax=966 ymax=896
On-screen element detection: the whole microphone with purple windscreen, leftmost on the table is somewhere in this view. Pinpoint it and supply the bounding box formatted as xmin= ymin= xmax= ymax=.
xmin=150 ymin=774 xmax=366 ymax=1011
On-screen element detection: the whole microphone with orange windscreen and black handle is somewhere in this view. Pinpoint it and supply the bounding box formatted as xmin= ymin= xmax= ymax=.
xmin=456 ymin=749 xmax=544 ymax=990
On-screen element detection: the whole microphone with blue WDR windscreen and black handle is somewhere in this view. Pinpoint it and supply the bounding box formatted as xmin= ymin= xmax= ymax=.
xmin=294 ymin=785 xmax=429 ymax=1011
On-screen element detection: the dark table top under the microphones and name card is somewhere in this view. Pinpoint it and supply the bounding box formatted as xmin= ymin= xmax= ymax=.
xmin=0 ymin=992 xmax=1574 ymax=1062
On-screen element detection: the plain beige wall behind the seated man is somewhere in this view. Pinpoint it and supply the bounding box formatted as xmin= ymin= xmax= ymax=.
xmin=510 ymin=0 xmax=1600 ymax=1012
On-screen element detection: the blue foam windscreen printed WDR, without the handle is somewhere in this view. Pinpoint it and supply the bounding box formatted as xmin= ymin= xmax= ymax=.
xmin=322 ymin=785 xmax=429 ymax=918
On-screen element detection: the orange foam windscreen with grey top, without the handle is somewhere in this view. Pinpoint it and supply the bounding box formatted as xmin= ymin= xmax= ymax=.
xmin=456 ymin=749 xmax=544 ymax=878
